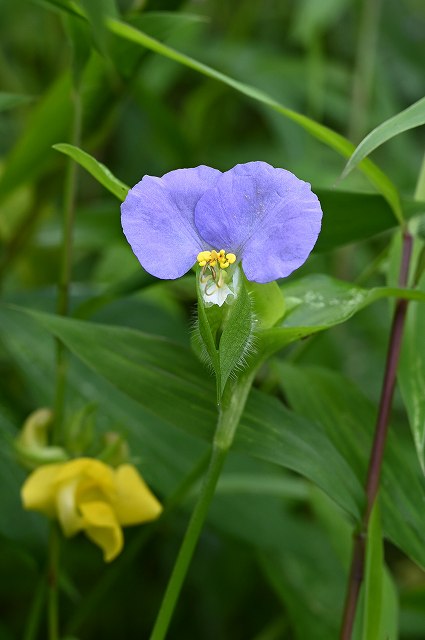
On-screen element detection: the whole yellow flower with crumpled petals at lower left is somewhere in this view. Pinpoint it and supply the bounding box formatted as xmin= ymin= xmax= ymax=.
xmin=21 ymin=458 xmax=162 ymax=562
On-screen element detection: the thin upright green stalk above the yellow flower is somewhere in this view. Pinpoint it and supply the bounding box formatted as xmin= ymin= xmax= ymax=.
xmin=53 ymin=88 xmax=82 ymax=444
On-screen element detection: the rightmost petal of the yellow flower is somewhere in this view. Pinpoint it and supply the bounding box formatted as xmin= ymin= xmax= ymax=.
xmin=111 ymin=464 xmax=162 ymax=525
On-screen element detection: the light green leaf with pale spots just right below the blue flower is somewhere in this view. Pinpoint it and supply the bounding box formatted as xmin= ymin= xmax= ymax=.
xmin=259 ymin=275 xmax=425 ymax=353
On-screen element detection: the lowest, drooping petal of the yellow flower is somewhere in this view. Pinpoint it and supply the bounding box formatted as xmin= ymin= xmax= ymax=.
xmin=80 ymin=502 xmax=123 ymax=562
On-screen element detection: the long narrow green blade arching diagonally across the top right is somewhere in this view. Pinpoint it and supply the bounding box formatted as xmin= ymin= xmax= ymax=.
xmin=106 ymin=19 xmax=403 ymax=222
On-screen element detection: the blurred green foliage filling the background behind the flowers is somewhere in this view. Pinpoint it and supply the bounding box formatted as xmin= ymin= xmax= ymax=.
xmin=0 ymin=0 xmax=425 ymax=640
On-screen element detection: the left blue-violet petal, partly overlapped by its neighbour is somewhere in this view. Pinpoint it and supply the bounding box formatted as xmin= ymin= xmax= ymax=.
xmin=121 ymin=166 xmax=221 ymax=280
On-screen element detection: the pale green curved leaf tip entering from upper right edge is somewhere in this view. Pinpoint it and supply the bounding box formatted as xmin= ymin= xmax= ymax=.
xmin=342 ymin=98 xmax=425 ymax=178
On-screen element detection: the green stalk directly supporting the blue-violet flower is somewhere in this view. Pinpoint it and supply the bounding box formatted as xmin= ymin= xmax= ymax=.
xmin=150 ymin=371 xmax=254 ymax=640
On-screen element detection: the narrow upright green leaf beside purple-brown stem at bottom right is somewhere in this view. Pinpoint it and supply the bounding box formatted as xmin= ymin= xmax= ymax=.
xmin=362 ymin=503 xmax=385 ymax=640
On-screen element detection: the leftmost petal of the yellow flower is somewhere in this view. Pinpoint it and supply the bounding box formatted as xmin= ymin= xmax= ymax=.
xmin=21 ymin=463 xmax=62 ymax=517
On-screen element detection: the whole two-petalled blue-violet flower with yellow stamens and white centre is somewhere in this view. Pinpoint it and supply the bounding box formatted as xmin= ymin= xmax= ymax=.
xmin=121 ymin=162 xmax=322 ymax=305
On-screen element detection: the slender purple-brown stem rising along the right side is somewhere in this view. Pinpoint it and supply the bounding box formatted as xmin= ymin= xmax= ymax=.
xmin=340 ymin=231 xmax=413 ymax=640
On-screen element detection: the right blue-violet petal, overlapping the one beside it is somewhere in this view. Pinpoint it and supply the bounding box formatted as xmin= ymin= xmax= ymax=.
xmin=195 ymin=162 xmax=322 ymax=282
